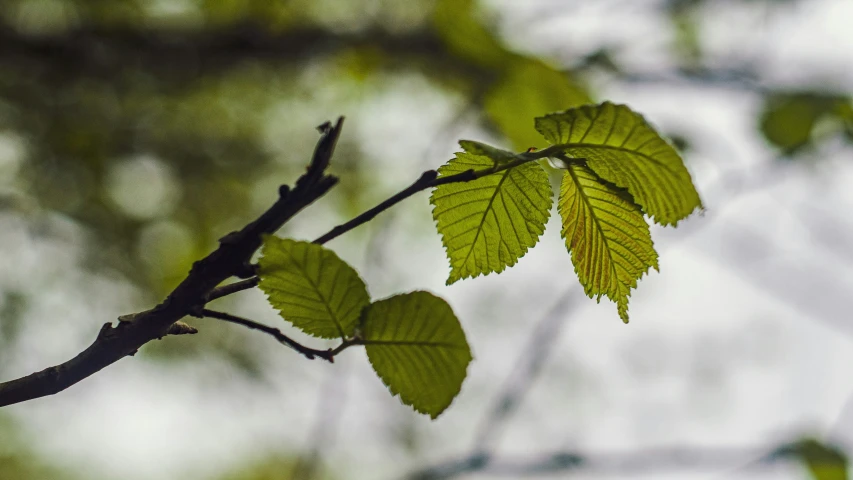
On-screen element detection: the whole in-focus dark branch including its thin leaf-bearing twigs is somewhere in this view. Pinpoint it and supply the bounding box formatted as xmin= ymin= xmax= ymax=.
xmin=0 ymin=117 xmax=561 ymax=407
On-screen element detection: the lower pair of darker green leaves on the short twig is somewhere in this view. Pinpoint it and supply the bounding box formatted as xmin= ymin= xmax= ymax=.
xmin=258 ymin=236 xmax=471 ymax=418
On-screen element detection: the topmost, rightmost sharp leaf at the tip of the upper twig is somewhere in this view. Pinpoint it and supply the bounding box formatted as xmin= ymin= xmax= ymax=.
xmin=536 ymin=102 xmax=702 ymax=225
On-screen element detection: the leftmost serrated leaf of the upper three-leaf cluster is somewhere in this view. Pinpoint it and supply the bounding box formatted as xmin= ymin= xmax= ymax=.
xmin=430 ymin=146 xmax=552 ymax=285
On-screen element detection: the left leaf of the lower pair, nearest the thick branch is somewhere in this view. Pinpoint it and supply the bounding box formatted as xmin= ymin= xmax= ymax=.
xmin=258 ymin=236 xmax=370 ymax=338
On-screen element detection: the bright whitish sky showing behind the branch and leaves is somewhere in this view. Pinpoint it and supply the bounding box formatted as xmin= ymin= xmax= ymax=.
xmin=0 ymin=0 xmax=853 ymax=480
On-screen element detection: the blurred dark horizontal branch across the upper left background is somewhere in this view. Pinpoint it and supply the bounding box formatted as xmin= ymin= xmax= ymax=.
xmin=0 ymin=22 xmax=490 ymax=84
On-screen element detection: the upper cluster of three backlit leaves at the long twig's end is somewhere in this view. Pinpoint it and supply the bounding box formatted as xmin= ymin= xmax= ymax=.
xmin=431 ymin=102 xmax=702 ymax=323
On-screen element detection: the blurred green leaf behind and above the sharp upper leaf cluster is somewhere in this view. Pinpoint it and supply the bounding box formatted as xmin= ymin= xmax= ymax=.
xmin=483 ymin=59 xmax=592 ymax=150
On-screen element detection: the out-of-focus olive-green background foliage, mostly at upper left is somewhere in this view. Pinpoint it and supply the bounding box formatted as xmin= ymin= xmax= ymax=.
xmin=0 ymin=0 xmax=853 ymax=480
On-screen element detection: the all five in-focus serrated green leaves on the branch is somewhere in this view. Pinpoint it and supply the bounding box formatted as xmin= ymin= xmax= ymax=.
xmin=258 ymin=103 xmax=701 ymax=418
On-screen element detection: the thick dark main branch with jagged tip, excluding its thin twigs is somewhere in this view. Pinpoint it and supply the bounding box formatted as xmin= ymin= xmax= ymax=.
xmin=0 ymin=117 xmax=343 ymax=407
